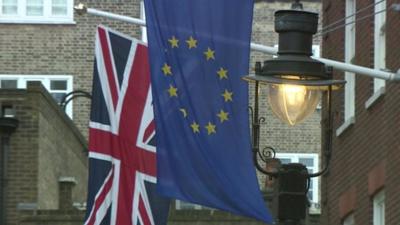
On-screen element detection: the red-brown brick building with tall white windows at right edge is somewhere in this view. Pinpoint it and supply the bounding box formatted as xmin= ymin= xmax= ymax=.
xmin=321 ymin=0 xmax=400 ymax=225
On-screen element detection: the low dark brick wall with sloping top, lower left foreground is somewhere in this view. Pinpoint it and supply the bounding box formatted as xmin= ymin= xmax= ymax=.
xmin=0 ymin=83 xmax=87 ymax=225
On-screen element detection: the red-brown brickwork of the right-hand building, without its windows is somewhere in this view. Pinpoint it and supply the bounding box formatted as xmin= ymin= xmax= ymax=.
xmin=321 ymin=0 xmax=400 ymax=225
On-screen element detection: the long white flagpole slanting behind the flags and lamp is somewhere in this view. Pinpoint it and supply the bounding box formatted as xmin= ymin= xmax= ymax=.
xmin=74 ymin=3 xmax=400 ymax=81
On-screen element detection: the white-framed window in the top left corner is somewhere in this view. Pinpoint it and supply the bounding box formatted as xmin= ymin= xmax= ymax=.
xmin=0 ymin=0 xmax=74 ymax=24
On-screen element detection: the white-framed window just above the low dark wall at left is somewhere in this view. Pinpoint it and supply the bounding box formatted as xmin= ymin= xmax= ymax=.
xmin=0 ymin=75 xmax=72 ymax=119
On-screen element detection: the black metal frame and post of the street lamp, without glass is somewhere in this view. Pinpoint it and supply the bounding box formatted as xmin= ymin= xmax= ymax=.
xmin=244 ymin=10 xmax=345 ymax=225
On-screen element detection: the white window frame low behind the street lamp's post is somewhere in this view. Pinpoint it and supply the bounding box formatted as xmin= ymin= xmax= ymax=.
xmin=276 ymin=153 xmax=320 ymax=210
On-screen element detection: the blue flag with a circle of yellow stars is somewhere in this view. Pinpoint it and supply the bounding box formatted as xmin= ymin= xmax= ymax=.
xmin=145 ymin=0 xmax=271 ymax=223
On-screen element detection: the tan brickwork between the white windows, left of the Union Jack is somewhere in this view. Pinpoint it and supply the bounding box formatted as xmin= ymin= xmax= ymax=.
xmin=0 ymin=0 xmax=140 ymax=137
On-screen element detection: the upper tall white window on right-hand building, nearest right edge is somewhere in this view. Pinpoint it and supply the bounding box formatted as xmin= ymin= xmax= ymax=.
xmin=365 ymin=0 xmax=386 ymax=109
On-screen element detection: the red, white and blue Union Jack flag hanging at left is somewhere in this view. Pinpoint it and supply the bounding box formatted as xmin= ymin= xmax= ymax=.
xmin=85 ymin=26 xmax=169 ymax=225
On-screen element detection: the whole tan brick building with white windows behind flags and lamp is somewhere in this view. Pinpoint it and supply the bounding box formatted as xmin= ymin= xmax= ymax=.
xmin=0 ymin=0 xmax=321 ymax=224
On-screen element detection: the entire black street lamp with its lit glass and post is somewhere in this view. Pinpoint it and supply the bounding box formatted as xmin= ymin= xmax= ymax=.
xmin=244 ymin=10 xmax=345 ymax=225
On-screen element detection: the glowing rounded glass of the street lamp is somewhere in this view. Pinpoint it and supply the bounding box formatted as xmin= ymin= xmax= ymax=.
xmin=267 ymin=84 xmax=322 ymax=125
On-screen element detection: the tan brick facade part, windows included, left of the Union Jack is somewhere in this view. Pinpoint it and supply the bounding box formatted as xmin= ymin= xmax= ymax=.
xmin=0 ymin=0 xmax=141 ymax=137
